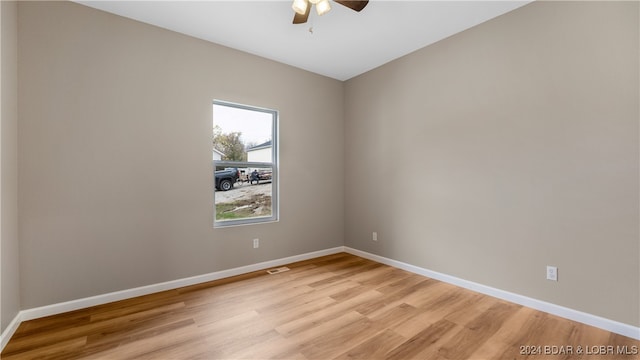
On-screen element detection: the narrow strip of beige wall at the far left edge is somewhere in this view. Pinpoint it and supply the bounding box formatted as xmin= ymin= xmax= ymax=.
xmin=0 ymin=1 xmax=20 ymax=333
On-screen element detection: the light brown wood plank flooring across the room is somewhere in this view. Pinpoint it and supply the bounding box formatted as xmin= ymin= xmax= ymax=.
xmin=1 ymin=253 xmax=640 ymax=360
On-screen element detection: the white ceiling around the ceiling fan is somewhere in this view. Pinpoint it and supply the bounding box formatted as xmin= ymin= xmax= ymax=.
xmin=77 ymin=0 xmax=531 ymax=80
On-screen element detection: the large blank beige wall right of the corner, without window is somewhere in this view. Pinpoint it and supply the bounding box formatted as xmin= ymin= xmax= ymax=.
xmin=345 ymin=2 xmax=640 ymax=326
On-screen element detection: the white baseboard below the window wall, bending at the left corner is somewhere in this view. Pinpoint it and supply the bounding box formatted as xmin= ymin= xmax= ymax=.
xmin=0 ymin=246 xmax=344 ymax=351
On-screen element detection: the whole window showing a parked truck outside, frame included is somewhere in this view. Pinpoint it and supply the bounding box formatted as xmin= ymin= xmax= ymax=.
xmin=212 ymin=100 xmax=278 ymax=227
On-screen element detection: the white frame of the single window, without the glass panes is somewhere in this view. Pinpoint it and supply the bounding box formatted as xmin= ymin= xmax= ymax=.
xmin=212 ymin=100 xmax=280 ymax=228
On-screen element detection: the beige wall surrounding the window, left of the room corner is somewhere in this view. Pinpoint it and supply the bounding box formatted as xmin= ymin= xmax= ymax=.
xmin=18 ymin=2 xmax=344 ymax=309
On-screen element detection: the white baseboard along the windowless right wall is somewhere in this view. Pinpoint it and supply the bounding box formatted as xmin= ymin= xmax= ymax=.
xmin=344 ymin=247 xmax=640 ymax=340
